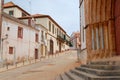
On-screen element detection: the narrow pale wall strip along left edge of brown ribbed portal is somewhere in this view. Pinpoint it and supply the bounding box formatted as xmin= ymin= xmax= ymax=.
xmin=79 ymin=0 xmax=87 ymax=64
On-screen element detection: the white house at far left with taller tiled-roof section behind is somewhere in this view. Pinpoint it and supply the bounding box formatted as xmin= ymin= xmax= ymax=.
xmin=1 ymin=2 xmax=40 ymax=63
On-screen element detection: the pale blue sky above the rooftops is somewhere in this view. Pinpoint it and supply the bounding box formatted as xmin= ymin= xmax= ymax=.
xmin=4 ymin=0 xmax=80 ymax=35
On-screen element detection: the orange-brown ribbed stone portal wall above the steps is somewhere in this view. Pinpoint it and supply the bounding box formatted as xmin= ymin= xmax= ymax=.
xmin=85 ymin=0 xmax=115 ymax=60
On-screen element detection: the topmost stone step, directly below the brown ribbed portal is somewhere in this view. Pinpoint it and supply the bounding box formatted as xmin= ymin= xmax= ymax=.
xmin=88 ymin=61 xmax=120 ymax=65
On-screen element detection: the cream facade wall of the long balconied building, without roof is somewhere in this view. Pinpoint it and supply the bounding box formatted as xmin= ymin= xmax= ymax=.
xmin=36 ymin=18 xmax=69 ymax=53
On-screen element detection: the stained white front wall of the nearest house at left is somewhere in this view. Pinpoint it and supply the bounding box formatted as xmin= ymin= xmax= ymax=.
xmin=2 ymin=13 xmax=39 ymax=61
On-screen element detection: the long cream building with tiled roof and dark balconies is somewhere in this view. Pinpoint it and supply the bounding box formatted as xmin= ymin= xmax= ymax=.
xmin=19 ymin=14 xmax=70 ymax=55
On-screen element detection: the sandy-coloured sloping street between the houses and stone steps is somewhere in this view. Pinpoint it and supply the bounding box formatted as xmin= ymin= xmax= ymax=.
xmin=0 ymin=51 xmax=80 ymax=80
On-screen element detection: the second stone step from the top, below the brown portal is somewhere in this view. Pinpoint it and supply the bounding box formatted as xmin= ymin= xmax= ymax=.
xmin=81 ymin=64 xmax=120 ymax=70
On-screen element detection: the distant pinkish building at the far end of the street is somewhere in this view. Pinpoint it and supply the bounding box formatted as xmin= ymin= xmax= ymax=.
xmin=70 ymin=32 xmax=81 ymax=49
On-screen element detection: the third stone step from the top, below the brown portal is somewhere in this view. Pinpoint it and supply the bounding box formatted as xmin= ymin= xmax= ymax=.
xmin=76 ymin=67 xmax=120 ymax=76
